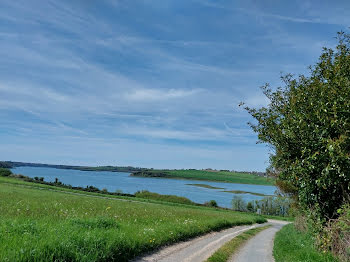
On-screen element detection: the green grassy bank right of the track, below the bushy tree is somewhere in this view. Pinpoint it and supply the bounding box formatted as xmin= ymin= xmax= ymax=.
xmin=273 ymin=224 xmax=338 ymax=262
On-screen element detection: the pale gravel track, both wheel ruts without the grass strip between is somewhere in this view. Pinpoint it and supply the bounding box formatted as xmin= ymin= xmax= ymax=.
xmin=132 ymin=220 xmax=288 ymax=262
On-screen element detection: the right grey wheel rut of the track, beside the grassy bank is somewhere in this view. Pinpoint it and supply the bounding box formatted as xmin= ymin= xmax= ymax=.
xmin=229 ymin=220 xmax=288 ymax=262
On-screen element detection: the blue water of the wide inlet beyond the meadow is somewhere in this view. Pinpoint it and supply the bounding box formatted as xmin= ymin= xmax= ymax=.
xmin=12 ymin=167 xmax=276 ymax=207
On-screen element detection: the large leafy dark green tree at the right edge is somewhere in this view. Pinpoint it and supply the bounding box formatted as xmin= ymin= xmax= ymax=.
xmin=246 ymin=32 xmax=350 ymax=220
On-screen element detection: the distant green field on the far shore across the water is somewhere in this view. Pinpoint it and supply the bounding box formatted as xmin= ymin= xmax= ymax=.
xmin=134 ymin=170 xmax=275 ymax=185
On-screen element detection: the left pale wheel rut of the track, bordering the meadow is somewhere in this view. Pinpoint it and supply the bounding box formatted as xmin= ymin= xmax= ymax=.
xmin=133 ymin=225 xmax=262 ymax=262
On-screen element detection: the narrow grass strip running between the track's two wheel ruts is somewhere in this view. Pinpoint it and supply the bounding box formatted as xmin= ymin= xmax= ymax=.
xmin=207 ymin=225 xmax=270 ymax=262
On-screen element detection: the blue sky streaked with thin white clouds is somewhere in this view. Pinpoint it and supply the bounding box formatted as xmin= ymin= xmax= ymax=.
xmin=0 ymin=0 xmax=350 ymax=170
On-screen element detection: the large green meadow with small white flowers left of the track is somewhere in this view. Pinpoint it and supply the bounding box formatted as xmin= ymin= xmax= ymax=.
xmin=0 ymin=178 xmax=264 ymax=261
